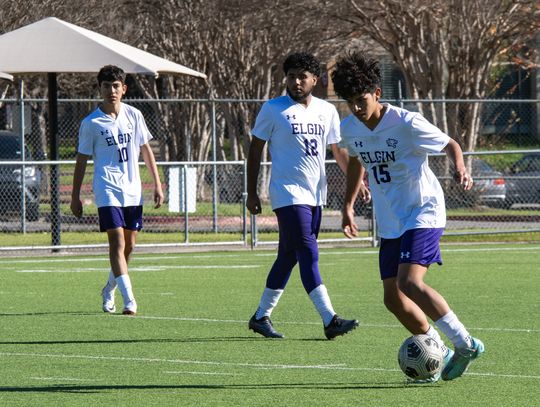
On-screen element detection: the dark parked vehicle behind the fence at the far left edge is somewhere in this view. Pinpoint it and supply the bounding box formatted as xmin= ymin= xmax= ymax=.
xmin=0 ymin=131 xmax=42 ymax=221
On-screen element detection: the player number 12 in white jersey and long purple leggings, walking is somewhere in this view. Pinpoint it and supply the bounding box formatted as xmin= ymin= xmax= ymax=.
xmin=246 ymin=52 xmax=368 ymax=339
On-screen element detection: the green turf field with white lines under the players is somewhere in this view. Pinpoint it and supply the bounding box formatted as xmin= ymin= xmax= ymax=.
xmin=0 ymin=244 xmax=540 ymax=406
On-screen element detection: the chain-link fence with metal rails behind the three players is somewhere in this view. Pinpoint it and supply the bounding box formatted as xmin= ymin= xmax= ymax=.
xmin=0 ymin=99 xmax=540 ymax=252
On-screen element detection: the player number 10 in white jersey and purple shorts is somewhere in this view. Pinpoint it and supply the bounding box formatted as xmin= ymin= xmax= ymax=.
xmin=71 ymin=65 xmax=163 ymax=315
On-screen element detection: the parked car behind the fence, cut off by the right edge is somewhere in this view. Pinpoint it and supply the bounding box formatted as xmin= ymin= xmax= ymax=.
xmin=506 ymin=153 xmax=540 ymax=207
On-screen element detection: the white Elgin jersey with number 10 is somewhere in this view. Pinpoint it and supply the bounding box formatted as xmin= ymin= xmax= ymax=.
xmin=78 ymin=103 xmax=152 ymax=207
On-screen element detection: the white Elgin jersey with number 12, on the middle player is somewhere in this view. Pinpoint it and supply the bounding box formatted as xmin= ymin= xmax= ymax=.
xmin=252 ymin=95 xmax=341 ymax=209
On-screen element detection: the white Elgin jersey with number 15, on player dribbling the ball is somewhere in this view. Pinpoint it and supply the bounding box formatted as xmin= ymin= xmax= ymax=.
xmin=341 ymin=104 xmax=450 ymax=239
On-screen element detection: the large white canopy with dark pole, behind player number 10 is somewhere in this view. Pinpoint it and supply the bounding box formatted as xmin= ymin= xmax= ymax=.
xmin=0 ymin=17 xmax=206 ymax=245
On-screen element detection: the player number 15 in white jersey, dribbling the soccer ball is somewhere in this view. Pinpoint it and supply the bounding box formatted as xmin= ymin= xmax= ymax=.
xmin=332 ymin=52 xmax=484 ymax=380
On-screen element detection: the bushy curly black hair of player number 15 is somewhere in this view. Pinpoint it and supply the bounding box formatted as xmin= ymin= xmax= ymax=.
xmin=332 ymin=51 xmax=381 ymax=100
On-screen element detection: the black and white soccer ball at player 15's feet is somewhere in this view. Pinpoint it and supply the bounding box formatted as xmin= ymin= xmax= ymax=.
xmin=398 ymin=335 xmax=444 ymax=380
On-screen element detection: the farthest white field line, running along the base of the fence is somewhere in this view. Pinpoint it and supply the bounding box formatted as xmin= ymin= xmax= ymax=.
xmin=2 ymin=245 xmax=540 ymax=265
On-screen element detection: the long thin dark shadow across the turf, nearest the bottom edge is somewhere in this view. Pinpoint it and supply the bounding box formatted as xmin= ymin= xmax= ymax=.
xmin=0 ymin=379 xmax=426 ymax=394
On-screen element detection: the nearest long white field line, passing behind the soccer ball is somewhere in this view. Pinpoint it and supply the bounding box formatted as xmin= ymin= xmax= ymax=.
xmin=0 ymin=352 xmax=540 ymax=380
